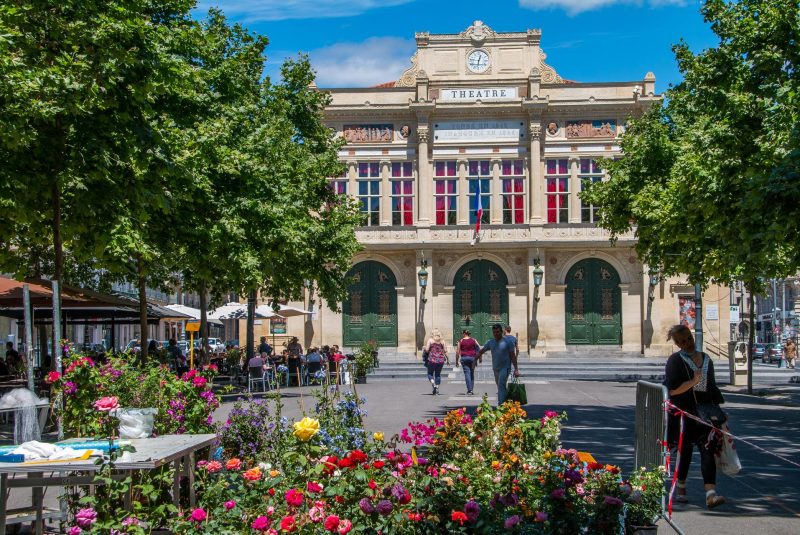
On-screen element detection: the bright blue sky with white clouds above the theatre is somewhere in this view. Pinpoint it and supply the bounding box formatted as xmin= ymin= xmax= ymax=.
xmin=196 ymin=0 xmax=716 ymax=92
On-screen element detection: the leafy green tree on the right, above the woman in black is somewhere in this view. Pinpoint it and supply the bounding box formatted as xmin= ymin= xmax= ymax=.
xmin=581 ymin=0 xmax=800 ymax=390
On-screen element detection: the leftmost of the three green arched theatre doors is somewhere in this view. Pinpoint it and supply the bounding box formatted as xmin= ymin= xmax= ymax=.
xmin=342 ymin=260 xmax=397 ymax=347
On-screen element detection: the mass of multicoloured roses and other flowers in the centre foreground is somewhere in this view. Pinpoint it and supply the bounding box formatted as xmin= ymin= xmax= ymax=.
xmin=173 ymin=389 xmax=663 ymax=535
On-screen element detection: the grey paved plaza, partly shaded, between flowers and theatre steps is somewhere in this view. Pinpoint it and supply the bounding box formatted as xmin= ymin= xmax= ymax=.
xmin=215 ymin=376 xmax=800 ymax=535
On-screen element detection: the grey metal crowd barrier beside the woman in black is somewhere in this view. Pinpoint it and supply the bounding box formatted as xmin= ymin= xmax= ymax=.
xmin=633 ymin=381 xmax=683 ymax=535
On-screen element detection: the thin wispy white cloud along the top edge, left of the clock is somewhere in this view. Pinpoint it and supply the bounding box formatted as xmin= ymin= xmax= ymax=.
xmin=197 ymin=0 xmax=413 ymax=22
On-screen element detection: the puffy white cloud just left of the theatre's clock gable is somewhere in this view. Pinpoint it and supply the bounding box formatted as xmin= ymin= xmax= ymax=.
xmin=309 ymin=37 xmax=417 ymax=87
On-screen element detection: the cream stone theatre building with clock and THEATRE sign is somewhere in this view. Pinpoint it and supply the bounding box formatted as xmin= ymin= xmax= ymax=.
xmin=302 ymin=21 xmax=729 ymax=358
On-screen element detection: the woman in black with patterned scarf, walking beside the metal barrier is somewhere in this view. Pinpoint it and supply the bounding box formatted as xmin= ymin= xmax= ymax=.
xmin=664 ymin=325 xmax=725 ymax=509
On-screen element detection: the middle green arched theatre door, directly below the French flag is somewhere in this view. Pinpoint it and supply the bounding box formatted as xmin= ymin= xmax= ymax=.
xmin=453 ymin=260 xmax=508 ymax=344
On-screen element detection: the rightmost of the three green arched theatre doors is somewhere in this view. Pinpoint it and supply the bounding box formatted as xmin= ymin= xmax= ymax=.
xmin=566 ymin=258 xmax=622 ymax=345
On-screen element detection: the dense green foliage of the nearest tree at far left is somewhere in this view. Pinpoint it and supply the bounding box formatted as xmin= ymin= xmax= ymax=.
xmin=0 ymin=0 xmax=193 ymax=360
